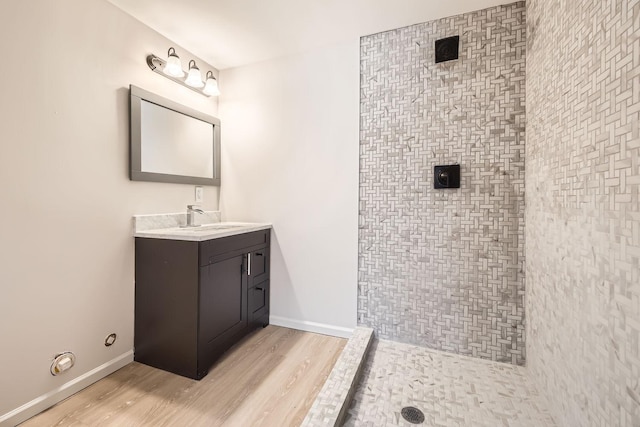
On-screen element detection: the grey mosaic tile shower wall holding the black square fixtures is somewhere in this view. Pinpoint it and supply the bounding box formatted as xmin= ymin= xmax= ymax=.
xmin=358 ymin=2 xmax=526 ymax=364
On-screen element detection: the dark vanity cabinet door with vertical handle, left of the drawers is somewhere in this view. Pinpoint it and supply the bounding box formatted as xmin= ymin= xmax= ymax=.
xmin=198 ymin=255 xmax=247 ymax=344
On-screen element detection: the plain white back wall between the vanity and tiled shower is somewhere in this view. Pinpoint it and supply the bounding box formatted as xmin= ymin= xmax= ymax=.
xmin=220 ymin=39 xmax=359 ymax=334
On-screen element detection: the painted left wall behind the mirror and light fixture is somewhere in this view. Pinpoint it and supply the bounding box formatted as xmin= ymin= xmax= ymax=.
xmin=0 ymin=0 xmax=218 ymax=424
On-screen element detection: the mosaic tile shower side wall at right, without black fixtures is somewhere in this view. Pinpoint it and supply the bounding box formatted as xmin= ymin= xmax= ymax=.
xmin=526 ymin=0 xmax=640 ymax=427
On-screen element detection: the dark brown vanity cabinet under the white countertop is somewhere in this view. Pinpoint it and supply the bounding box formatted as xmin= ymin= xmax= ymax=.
xmin=134 ymin=230 xmax=270 ymax=379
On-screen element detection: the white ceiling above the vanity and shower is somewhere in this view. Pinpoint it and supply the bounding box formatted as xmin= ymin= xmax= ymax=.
xmin=107 ymin=0 xmax=513 ymax=69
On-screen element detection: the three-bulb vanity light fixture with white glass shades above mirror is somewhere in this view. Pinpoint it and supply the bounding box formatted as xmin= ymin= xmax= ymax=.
xmin=147 ymin=47 xmax=220 ymax=96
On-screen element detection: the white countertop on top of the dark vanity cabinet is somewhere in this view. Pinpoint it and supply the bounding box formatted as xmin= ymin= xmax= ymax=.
xmin=133 ymin=222 xmax=271 ymax=242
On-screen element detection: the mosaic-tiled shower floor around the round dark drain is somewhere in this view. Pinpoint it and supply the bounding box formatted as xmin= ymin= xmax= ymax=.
xmin=344 ymin=340 xmax=556 ymax=427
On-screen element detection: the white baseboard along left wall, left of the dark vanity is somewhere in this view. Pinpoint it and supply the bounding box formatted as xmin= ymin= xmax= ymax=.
xmin=0 ymin=350 xmax=133 ymax=427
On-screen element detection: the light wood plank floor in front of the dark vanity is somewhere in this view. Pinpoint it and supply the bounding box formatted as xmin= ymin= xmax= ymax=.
xmin=20 ymin=326 xmax=347 ymax=427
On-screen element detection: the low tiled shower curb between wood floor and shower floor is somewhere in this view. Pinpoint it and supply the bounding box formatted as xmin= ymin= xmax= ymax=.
xmin=301 ymin=327 xmax=373 ymax=427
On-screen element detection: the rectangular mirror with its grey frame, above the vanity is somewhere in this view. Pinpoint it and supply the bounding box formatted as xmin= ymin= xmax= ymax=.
xmin=129 ymin=85 xmax=220 ymax=185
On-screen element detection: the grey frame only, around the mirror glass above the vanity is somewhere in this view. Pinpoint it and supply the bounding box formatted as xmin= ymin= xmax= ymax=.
xmin=129 ymin=85 xmax=220 ymax=186
